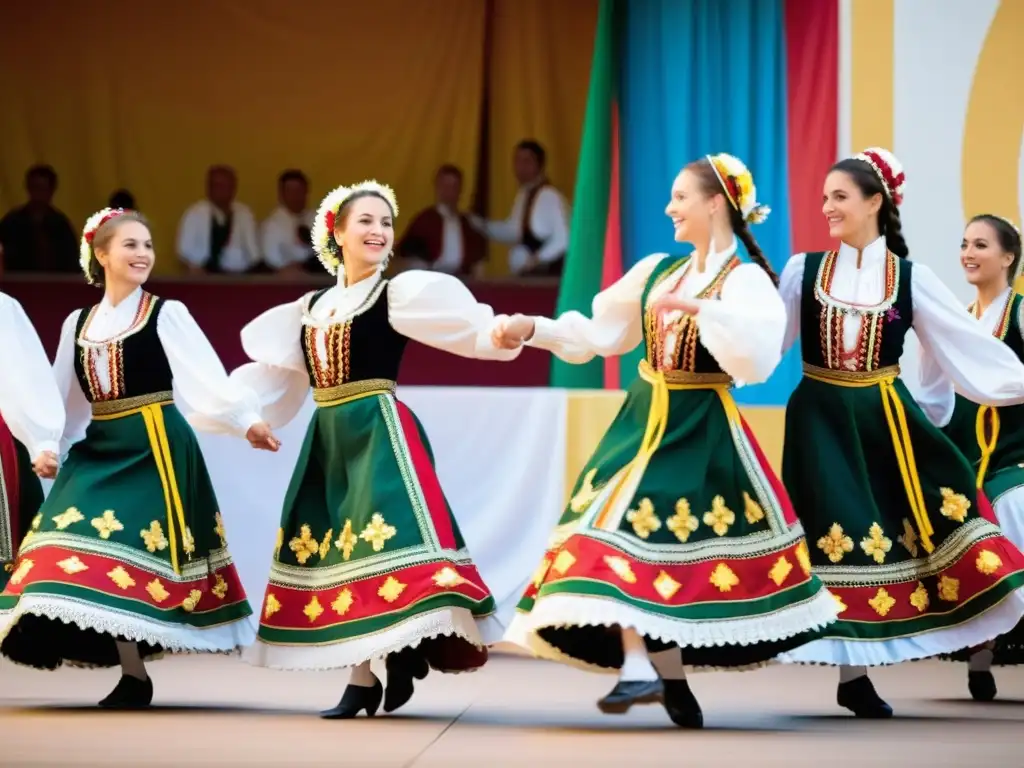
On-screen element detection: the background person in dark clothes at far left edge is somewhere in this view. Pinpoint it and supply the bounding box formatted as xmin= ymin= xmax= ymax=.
xmin=0 ymin=165 xmax=79 ymax=272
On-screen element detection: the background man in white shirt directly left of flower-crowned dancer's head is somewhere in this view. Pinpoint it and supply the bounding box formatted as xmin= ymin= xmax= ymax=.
xmin=260 ymin=170 xmax=315 ymax=274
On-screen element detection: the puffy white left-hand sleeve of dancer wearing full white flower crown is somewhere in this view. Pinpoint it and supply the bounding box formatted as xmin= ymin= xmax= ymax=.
xmin=230 ymin=295 xmax=309 ymax=429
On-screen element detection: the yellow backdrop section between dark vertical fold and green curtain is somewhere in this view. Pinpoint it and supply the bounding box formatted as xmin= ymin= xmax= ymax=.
xmin=487 ymin=0 xmax=603 ymax=275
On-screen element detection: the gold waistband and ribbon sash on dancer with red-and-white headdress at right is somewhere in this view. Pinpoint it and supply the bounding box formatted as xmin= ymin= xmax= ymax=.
xmin=804 ymin=362 xmax=935 ymax=553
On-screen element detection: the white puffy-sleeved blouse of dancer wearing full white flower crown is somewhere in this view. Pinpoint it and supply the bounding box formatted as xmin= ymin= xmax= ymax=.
xmin=215 ymin=269 xmax=521 ymax=431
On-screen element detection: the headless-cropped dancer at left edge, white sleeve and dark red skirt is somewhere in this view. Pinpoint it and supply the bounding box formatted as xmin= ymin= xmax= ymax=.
xmin=0 ymin=293 xmax=65 ymax=593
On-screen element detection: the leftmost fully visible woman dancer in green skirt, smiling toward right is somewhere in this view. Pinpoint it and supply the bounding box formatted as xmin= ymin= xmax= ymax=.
xmin=0 ymin=209 xmax=276 ymax=708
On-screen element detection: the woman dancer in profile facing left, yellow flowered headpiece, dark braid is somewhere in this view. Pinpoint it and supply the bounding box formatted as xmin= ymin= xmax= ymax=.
xmin=496 ymin=155 xmax=836 ymax=728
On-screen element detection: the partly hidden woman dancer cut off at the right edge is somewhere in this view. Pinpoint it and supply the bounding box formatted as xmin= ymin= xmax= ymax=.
xmin=921 ymin=213 xmax=1024 ymax=701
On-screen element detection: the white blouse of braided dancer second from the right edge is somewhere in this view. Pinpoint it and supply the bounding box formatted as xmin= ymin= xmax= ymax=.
xmin=779 ymin=238 xmax=1024 ymax=424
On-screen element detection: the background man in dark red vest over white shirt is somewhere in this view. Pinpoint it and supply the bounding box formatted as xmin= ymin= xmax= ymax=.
xmin=396 ymin=165 xmax=487 ymax=276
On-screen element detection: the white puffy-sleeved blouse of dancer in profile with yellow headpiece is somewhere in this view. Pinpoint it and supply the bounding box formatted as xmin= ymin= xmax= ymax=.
xmin=526 ymin=241 xmax=785 ymax=385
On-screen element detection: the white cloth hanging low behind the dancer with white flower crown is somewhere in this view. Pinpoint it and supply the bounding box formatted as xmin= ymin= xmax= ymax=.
xmin=192 ymin=387 xmax=567 ymax=626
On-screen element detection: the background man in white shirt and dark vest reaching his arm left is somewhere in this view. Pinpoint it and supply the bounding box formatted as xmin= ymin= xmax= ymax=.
xmin=472 ymin=139 xmax=569 ymax=276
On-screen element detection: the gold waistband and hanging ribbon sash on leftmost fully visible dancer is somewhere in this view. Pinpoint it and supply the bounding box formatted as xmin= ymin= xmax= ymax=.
xmin=92 ymin=392 xmax=195 ymax=573
